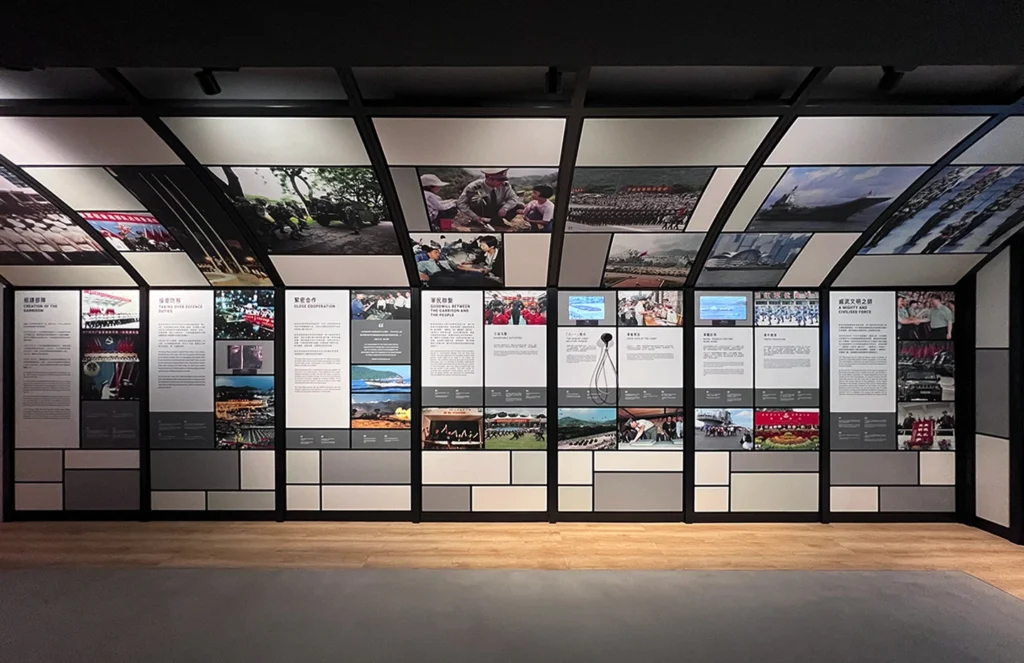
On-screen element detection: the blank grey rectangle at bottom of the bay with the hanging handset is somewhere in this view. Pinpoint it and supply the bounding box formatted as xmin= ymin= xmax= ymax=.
xmin=594 ymin=471 xmax=683 ymax=511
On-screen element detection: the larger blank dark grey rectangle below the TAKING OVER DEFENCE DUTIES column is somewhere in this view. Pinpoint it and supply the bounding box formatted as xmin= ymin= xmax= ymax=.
xmin=150 ymin=450 xmax=240 ymax=491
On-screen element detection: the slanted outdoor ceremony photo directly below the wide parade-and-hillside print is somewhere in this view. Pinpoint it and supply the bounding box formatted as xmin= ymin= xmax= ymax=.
xmin=604 ymin=233 xmax=705 ymax=289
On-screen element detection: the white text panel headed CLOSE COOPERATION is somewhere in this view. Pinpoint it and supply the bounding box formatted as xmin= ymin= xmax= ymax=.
xmin=285 ymin=290 xmax=351 ymax=428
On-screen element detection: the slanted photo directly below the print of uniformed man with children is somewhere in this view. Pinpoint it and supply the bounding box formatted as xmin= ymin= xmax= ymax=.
xmin=410 ymin=233 xmax=505 ymax=288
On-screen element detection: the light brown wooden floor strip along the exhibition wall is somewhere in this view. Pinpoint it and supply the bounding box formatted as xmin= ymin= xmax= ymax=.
xmin=0 ymin=523 xmax=1024 ymax=598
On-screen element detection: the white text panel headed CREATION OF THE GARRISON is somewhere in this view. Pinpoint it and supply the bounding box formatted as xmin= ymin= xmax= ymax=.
xmin=14 ymin=290 xmax=82 ymax=449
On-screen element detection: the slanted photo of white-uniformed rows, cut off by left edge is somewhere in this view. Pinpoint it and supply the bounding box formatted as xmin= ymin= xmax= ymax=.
xmin=0 ymin=166 xmax=114 ymax=264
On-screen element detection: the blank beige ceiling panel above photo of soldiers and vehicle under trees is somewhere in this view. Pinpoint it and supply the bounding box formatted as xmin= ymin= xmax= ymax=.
xmin=164 ymin=118 xmax=370 ymax=166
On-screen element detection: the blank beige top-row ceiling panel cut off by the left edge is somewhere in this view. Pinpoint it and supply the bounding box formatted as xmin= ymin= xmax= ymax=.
xmin=0 ymin=117 xmax=181 ymax=166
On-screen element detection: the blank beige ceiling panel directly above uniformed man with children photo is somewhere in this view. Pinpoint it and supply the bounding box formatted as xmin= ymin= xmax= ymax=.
xmin=374 ymin=118 xmax=567 ymax=167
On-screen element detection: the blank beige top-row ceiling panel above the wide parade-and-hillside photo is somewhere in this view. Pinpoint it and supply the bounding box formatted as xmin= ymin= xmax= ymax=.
xmin=577 ymin=118 xmax=775 ymax=166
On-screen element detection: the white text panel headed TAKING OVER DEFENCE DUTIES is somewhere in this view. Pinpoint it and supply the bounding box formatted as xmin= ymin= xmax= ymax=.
xmin=150 ymin=290 xmax=214 ymax=412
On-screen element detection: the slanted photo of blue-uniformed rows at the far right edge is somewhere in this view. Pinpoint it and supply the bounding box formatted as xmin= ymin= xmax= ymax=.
xmin=860 ymin=166 xmax=1024 ymax=255
